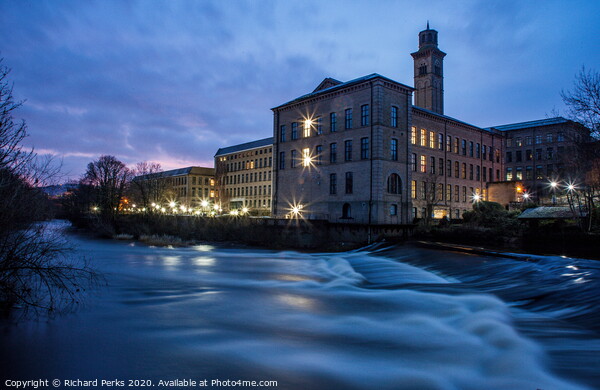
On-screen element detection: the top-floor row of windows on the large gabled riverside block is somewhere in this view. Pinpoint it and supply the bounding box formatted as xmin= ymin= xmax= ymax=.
xmin=279 ymin=104 xmax=398 ymax=142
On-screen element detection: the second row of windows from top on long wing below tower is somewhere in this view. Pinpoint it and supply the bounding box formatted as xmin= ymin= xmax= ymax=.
xmin=410 ymin=153 xmax=500 ymax=181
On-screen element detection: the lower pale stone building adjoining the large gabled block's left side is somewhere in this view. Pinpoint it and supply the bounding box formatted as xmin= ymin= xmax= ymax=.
xmin=215 ymin=137 xmax=273 ymax=215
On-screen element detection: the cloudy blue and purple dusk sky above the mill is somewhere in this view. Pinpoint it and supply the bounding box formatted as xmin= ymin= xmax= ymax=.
xmin=0 ymin=0 xmax=600 ymax=179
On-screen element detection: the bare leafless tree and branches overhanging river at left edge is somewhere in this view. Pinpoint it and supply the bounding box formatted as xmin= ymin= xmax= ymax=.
xmin=0 ymin=60 xmax=95 ymax=313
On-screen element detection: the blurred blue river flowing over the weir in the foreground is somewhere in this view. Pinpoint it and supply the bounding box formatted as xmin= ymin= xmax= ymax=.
xmin=0 ymin=222 xmax=600 ymax=390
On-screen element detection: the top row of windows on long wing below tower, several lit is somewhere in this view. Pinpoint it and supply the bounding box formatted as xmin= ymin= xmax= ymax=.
xmin=410 ymin=126 xmax=500 ymax=163
